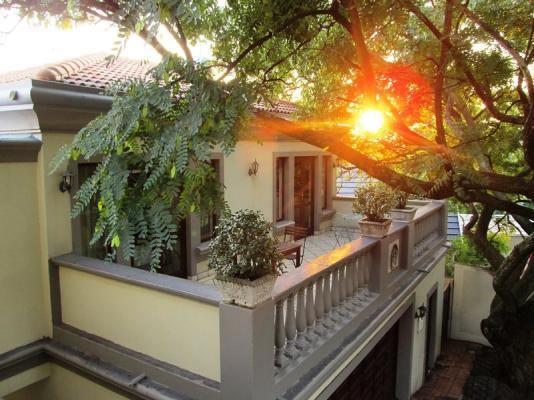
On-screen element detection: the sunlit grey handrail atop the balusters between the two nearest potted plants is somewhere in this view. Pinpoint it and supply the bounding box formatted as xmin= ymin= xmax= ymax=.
xmin=272 ymin=237 xmax=378 ymax=301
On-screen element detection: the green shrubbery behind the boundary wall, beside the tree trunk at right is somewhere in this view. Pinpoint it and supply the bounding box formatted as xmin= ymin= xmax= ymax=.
xmin=445 ymin=233 xmax=510 ymax=276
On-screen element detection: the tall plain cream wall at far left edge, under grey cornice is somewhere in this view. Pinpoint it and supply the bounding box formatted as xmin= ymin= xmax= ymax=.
xmin=0 ymin=163 xmax=47 ymax=354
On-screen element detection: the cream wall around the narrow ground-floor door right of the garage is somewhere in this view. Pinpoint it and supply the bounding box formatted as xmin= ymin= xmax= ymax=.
xmin=411 ymin=257 xmax=445 ymax=393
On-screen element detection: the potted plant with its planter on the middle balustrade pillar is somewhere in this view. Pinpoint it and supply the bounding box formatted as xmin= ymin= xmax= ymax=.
xmin=352 ymin=182 xmax=395 ymax=238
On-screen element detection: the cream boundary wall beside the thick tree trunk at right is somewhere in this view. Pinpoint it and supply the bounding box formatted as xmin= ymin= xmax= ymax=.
xmin=451 ymin=264 xmax=495 ymax=346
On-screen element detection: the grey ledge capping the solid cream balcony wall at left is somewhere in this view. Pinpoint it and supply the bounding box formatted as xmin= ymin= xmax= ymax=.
xmin=51 ymin=254 xmax=222 ymax=306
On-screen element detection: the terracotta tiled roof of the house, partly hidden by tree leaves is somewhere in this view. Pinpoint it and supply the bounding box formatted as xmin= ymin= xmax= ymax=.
xmin=0 ymin=54 xmax=297 ymax=114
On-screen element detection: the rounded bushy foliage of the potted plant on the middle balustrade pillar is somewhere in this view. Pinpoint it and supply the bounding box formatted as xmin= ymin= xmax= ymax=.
xmin=352 ymin=182 xmax=395 ymax=222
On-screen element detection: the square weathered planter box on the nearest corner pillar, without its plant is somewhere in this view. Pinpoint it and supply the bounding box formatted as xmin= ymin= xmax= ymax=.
xmin=214 ymin=275 xmax=277 ymax=308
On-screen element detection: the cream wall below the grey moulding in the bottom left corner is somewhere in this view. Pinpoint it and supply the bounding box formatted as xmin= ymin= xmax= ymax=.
xmin=5 ymin=364 xmax=126 ymax=400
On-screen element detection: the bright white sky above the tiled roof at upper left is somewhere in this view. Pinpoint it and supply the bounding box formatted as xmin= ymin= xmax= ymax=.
xmin=0 ymin=10 xmax=214 ymax=73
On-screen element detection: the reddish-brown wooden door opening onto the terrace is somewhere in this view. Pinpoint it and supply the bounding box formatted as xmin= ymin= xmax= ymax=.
xmin=294 ymin=157 xmax=315 ymax=235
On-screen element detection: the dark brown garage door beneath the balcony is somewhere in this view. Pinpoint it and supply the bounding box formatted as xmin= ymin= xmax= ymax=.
xmin=330 ymin=322 xmax=399 ymax=400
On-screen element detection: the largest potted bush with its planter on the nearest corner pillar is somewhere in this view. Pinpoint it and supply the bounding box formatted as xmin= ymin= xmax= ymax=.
xmin=208 ymin=210 xmax=283 ymax=308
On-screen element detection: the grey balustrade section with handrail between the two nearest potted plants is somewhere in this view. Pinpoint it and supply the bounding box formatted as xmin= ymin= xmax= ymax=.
xmin=273 ymin=241 xmax=378 ymax=369
